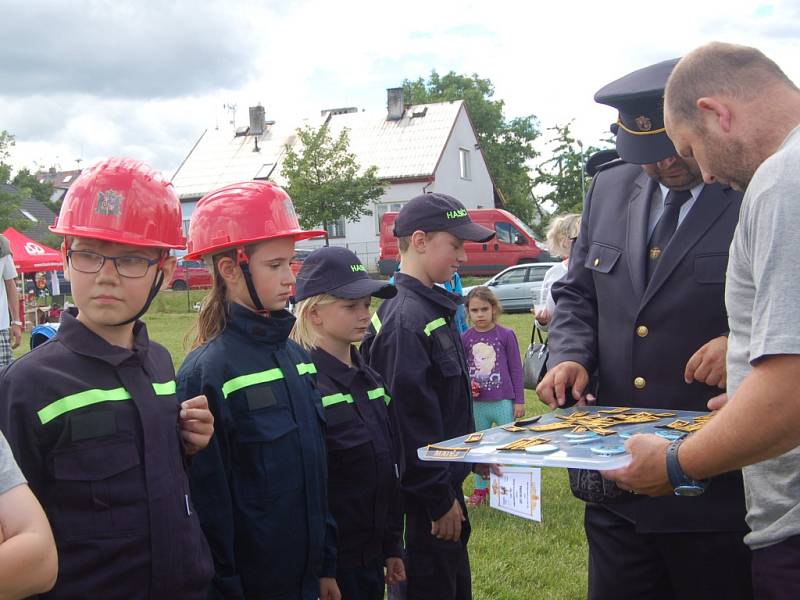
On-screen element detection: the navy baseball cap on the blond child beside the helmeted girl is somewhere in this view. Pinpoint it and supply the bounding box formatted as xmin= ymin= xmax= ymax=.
xmin=294 ymin=246 xmax=397 ymax=302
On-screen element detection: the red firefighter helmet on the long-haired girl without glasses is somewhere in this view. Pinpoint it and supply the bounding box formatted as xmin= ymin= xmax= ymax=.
xmin=186 ymin=181 xmax=325 ymax=259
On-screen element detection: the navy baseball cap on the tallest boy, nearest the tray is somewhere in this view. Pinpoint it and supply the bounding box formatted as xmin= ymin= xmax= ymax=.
xmin=394 ymin=194 xmax=494 ymax=242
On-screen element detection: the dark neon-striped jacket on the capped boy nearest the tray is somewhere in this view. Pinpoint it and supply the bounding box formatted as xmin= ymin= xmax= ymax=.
xmin=361 ymin=273 xmax=475 ymax=520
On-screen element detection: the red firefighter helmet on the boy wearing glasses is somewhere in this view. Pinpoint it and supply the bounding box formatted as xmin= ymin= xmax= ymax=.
xmin=50 ymin=158 xmax=186 ymax=248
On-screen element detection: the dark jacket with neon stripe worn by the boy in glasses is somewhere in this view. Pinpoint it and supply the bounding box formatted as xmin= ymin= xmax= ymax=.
xmin=0 ymin=313 xmax=213 ymax=600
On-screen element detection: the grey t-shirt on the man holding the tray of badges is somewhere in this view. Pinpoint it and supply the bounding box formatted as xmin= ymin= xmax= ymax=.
xmin=725 ymin=127 xmax=800 ymax=549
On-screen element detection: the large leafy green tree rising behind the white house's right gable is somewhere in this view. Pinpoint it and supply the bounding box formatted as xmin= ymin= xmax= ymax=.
xmin=403 ymin=71 xmax=539 ymax=222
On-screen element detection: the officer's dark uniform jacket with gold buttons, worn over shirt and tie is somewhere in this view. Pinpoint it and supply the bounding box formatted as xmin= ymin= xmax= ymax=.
xmin=548 ymin=163 xmax=745 ymax=531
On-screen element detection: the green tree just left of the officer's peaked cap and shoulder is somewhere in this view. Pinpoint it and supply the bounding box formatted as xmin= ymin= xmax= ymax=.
xmin=531 ymin=121 xmax=600 ymax=232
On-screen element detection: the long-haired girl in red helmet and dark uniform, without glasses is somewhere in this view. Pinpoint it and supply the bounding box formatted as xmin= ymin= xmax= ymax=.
xmin=178 ymin=181 xmax=341 ymax=600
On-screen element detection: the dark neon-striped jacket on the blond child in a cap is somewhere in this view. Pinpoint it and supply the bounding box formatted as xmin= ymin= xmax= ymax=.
xmin=311 ymin=347 xmax=402 ymax=567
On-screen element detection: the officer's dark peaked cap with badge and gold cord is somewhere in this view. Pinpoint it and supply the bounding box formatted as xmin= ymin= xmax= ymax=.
xmin=594 ymin=58 xmax=680 ymax=165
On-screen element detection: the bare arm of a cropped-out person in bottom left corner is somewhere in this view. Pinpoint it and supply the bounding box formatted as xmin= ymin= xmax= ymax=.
xmin=0 ymin=485 xmax=58 ymax=600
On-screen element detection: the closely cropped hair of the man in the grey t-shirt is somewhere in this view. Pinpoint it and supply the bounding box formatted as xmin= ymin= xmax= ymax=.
xmin=664 ymin=42 xmax=797 ymax=123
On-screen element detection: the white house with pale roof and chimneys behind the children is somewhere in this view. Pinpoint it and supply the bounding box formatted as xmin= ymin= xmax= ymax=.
xmin=172 ymin=88 xmax=495 ymax=270
